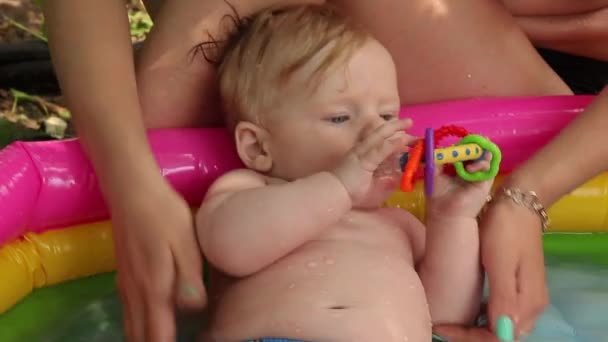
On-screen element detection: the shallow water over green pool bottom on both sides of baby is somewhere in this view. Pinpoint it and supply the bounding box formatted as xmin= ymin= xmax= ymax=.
xmin=0 ymin=234 xmax=608 ymax=342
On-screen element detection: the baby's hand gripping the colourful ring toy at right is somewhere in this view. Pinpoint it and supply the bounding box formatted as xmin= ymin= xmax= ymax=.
xmin=428 ymin=152 xmax=494 ymax=218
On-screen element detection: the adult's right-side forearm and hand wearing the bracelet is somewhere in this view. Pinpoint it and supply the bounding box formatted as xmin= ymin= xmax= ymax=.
xmin=481 ymin=89 xmax=608 ymax=335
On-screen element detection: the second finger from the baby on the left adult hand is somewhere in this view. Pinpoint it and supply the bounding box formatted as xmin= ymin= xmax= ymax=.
xmin=141 ymin=246 xmax=176 ymax=342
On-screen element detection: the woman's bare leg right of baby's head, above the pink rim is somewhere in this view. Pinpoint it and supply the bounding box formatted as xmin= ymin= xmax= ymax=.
xmin=334 ymin=0 xmax=571 ymax=103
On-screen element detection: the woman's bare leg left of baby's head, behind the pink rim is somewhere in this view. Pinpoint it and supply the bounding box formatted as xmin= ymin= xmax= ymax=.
xmin=137 ymin=0 xmax=323 ymax=128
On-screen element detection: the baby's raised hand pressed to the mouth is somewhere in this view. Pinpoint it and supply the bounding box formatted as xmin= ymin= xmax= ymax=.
xmin=333 ymin=119 xmax=416 ymax=207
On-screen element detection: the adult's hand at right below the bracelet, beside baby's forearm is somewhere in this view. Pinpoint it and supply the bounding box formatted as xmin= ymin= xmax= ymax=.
xmin=480 ymin=198 xmax=549 ymax=338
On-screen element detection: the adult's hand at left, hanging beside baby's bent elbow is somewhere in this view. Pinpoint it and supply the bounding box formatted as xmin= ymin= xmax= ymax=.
xmin=112 ymin=177 xmax=207 ymax=341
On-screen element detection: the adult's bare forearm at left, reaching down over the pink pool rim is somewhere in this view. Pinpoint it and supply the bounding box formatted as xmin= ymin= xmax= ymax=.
xmin=44 ymin=0 xmax=158 ymax=198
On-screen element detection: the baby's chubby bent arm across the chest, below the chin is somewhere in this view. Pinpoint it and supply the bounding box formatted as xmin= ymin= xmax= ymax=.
xmin=196 ymin=170 xmax=351 ymax=277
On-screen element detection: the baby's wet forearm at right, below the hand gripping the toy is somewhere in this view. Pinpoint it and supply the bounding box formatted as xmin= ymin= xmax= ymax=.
xmin=418 ymin=215 xmax=483 ymax=325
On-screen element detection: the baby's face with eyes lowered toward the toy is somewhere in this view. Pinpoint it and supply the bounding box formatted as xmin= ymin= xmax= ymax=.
xmin=264 ymin=39 xmax=400 ymax=180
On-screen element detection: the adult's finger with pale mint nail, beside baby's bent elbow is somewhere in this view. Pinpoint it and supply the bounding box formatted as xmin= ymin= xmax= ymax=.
xmin=172 ymin=235 xmax=207 ymax=309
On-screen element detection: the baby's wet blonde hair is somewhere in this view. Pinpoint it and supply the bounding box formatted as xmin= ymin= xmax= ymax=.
xmin=198 ymin=5 xmax=368 ymax=130
